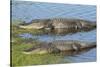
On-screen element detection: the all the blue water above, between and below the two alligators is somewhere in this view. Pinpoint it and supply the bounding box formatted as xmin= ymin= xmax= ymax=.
xmin=12 ymin=1 xmax=96 ymax=62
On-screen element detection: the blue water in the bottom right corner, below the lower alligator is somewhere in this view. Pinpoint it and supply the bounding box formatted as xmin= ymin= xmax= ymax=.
xmin=61 ymin=48 xmax=96 ymax=63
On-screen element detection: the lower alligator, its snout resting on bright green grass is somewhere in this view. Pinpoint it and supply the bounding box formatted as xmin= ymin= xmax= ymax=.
xmin=23 ymin=40 xmax=96 ymax=54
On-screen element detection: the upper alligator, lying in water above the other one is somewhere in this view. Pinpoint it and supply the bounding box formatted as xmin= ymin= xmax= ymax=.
xmin=19 ymin=18 xmax=96 ymax=30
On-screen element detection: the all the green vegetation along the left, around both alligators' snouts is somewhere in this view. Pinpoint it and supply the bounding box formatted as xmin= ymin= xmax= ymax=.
xmin=11 ymin=20 xmax=69 ymax=66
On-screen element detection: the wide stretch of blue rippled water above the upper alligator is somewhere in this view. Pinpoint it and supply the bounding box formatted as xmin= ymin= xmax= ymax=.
xmin=12 ymin=1 xmax=96 ymax=22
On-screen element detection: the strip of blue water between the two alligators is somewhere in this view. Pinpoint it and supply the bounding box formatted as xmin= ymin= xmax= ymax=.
xmin=19 ymin=30 xmax=96 ymax=42
